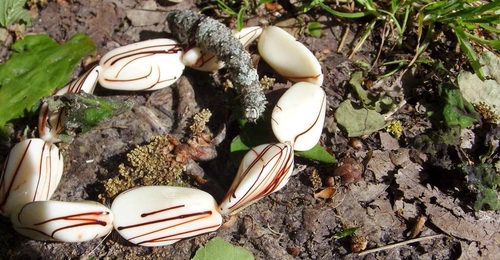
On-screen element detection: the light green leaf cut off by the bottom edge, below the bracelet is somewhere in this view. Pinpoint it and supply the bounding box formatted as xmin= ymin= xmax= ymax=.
xmin=192 ymin=237 xmax=254 ymax=260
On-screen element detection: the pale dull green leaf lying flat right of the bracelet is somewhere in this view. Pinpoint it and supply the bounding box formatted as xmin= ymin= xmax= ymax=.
xmin=335 ymin=100 xmax=385 ymax=137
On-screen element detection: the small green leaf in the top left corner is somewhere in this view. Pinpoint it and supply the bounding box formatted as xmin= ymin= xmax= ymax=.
xmin=0 ymin=0 xmax=31 ymax=27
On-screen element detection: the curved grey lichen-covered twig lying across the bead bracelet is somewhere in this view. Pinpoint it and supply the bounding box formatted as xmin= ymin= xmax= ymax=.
xmin=167 ymin=10 xmax=267 ymax=122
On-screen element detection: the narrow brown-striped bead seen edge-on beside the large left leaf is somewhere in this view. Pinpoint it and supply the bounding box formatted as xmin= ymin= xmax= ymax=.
xmin=38 ymin=66 xmax=101 ymax=143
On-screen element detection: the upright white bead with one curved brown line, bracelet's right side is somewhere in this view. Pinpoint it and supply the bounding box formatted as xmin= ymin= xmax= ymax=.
xmin=271 ymin=82 xmax=326 ymax=151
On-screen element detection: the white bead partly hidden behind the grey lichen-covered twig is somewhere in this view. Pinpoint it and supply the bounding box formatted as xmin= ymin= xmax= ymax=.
xmin=182 ymin=26 xmax=262 ymax=71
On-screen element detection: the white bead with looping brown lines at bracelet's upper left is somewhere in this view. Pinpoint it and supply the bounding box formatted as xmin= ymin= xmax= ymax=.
xmin=99 ymin=39 xmax=184 ymax=91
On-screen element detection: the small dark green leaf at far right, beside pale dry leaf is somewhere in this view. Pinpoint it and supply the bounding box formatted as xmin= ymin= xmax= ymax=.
xmin=442 ymin=84 xmax=479 ymax=128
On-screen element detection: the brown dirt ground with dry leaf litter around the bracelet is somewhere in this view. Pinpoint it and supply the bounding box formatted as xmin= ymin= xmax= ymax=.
xmin=0 ymin=0 xmax=500 ymax=259
